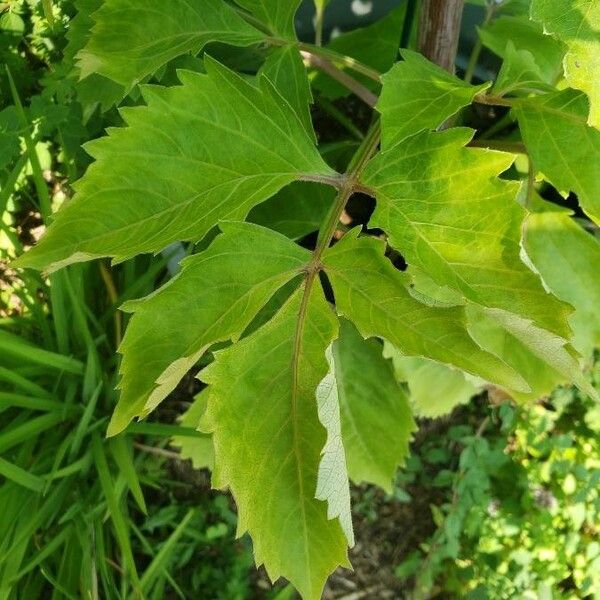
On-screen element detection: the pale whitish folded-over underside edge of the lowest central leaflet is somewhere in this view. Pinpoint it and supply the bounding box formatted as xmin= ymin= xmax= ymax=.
xmin=315 ymin=346 xmax=354 ymax=546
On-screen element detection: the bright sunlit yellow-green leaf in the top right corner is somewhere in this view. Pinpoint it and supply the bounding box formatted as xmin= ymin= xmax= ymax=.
xmin=531 ymin=0 xmax=600 ymax=128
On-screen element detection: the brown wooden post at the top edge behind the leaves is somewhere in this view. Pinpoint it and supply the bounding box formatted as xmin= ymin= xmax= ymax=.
xmin=419 ymin=0 xmax=465 ymax=73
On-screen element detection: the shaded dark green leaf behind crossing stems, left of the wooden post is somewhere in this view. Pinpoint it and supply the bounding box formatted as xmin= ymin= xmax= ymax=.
xmin=312 ymin=2 xmax=406 ymax=100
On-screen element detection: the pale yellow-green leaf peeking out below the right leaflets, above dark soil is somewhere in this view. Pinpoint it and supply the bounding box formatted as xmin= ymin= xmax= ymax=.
xmin=384 ymin=344 xmax=481 ymax=418
